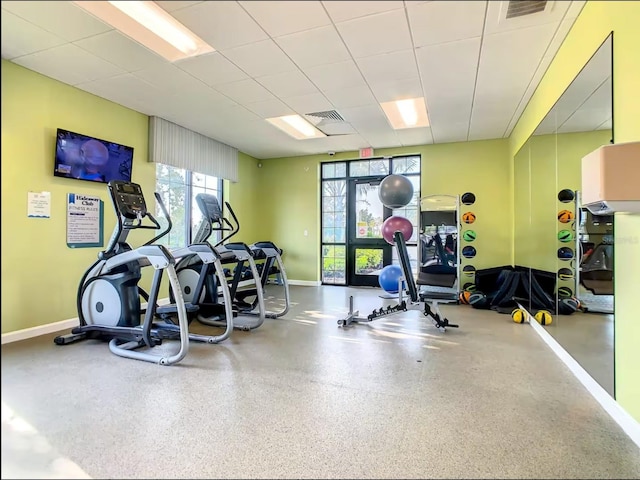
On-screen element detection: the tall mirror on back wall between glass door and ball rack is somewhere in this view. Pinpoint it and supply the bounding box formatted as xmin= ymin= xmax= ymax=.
xmin=417 ymin=195 xmax=460 ymax=302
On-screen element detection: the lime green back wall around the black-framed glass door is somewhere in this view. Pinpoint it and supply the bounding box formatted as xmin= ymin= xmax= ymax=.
xmin=258 ymin=140 xmax=513 ymax=281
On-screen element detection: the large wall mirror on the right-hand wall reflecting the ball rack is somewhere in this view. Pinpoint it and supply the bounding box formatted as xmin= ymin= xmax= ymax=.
xmin=514 ymin=33 xmax=615 ymax=396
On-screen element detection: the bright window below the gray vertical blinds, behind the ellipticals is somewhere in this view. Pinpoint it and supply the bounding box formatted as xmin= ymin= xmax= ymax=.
xmin=156 ymin=163 xmax=223 ymax=248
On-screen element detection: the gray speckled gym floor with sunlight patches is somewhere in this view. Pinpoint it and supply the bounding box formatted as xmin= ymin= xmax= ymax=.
xmin=2 ymin=287 xmax=640 ymax=478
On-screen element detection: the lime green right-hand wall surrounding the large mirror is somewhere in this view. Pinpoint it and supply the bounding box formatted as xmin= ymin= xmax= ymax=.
xmin=509 ymin=1 xmax=640 ymax=421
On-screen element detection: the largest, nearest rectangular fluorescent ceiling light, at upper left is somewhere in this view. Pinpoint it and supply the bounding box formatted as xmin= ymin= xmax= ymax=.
xmin=74 ymin=0 xmax=215 ymax=62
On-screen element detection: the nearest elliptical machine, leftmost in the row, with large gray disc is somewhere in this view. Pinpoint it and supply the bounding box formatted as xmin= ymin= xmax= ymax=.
xmin=54 ymin=181 xmax=197 ymax=365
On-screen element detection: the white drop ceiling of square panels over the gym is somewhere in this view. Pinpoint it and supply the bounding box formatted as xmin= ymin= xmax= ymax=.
xmin=1 ymin=0 xmax=585 ymax=159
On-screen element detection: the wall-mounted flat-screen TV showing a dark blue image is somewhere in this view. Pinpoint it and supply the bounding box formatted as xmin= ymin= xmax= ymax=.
xmin=53 ymin=128 xmax=133 ymax=183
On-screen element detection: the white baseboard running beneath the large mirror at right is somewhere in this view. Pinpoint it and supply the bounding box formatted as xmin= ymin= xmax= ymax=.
xmin=523 ymin=309 xmax=640 ymax=447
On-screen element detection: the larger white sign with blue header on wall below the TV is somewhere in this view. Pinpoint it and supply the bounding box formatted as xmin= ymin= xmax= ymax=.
xmin=67 ymin=193 xmax=104 ymax=248
